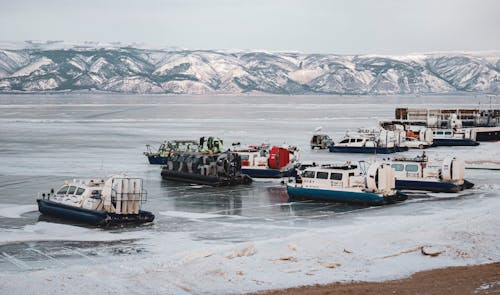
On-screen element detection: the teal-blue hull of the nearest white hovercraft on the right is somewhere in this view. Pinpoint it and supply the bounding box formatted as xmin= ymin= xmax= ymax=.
xmin=287 ymin=185 xmax=406 ymax=205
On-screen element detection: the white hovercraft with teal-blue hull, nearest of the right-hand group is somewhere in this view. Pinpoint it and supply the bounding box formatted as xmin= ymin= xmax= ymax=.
xmin=287 ymin=162 xmax=407 ymax=205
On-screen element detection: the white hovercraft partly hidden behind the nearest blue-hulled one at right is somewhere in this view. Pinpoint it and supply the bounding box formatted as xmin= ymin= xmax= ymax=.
xmin=387 ymin=152 xmax=474 ymax=193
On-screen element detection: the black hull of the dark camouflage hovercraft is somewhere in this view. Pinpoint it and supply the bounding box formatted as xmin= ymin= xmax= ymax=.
xmin=161 ymin=168 xmax=252 ymax=186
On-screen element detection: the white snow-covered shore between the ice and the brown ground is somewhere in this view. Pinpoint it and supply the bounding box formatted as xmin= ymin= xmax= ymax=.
xmin=0 ymin=188 xmax=500 ymax=294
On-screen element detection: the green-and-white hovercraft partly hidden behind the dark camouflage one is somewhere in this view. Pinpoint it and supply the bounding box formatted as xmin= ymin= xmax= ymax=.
xmin=144 ymin=140 xmax=199 ymax=165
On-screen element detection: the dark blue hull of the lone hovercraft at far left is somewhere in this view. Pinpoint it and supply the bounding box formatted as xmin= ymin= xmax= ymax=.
xmin=36 ymin=199 xmax=155 ymax=226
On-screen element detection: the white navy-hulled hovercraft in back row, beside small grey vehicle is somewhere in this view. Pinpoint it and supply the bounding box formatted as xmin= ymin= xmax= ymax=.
xmin=328 ymin=130 xmax=408 ymax=154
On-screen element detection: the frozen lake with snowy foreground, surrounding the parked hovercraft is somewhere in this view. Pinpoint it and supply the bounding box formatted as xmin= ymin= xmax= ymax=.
xmin=0 ymin=94 xmax=500 ymax=294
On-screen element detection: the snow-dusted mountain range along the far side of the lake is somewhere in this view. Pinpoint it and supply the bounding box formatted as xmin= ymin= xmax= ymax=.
xmin=0 ymin=43 xmax=500 ymax=95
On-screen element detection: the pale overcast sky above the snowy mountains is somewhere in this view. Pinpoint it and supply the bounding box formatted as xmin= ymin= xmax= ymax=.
xmin=0 ymin=0 xmax=500 ymax=54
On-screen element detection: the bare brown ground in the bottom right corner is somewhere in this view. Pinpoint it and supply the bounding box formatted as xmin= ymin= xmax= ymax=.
xmin=254 ymin=262 xmax=500 ymax=295
